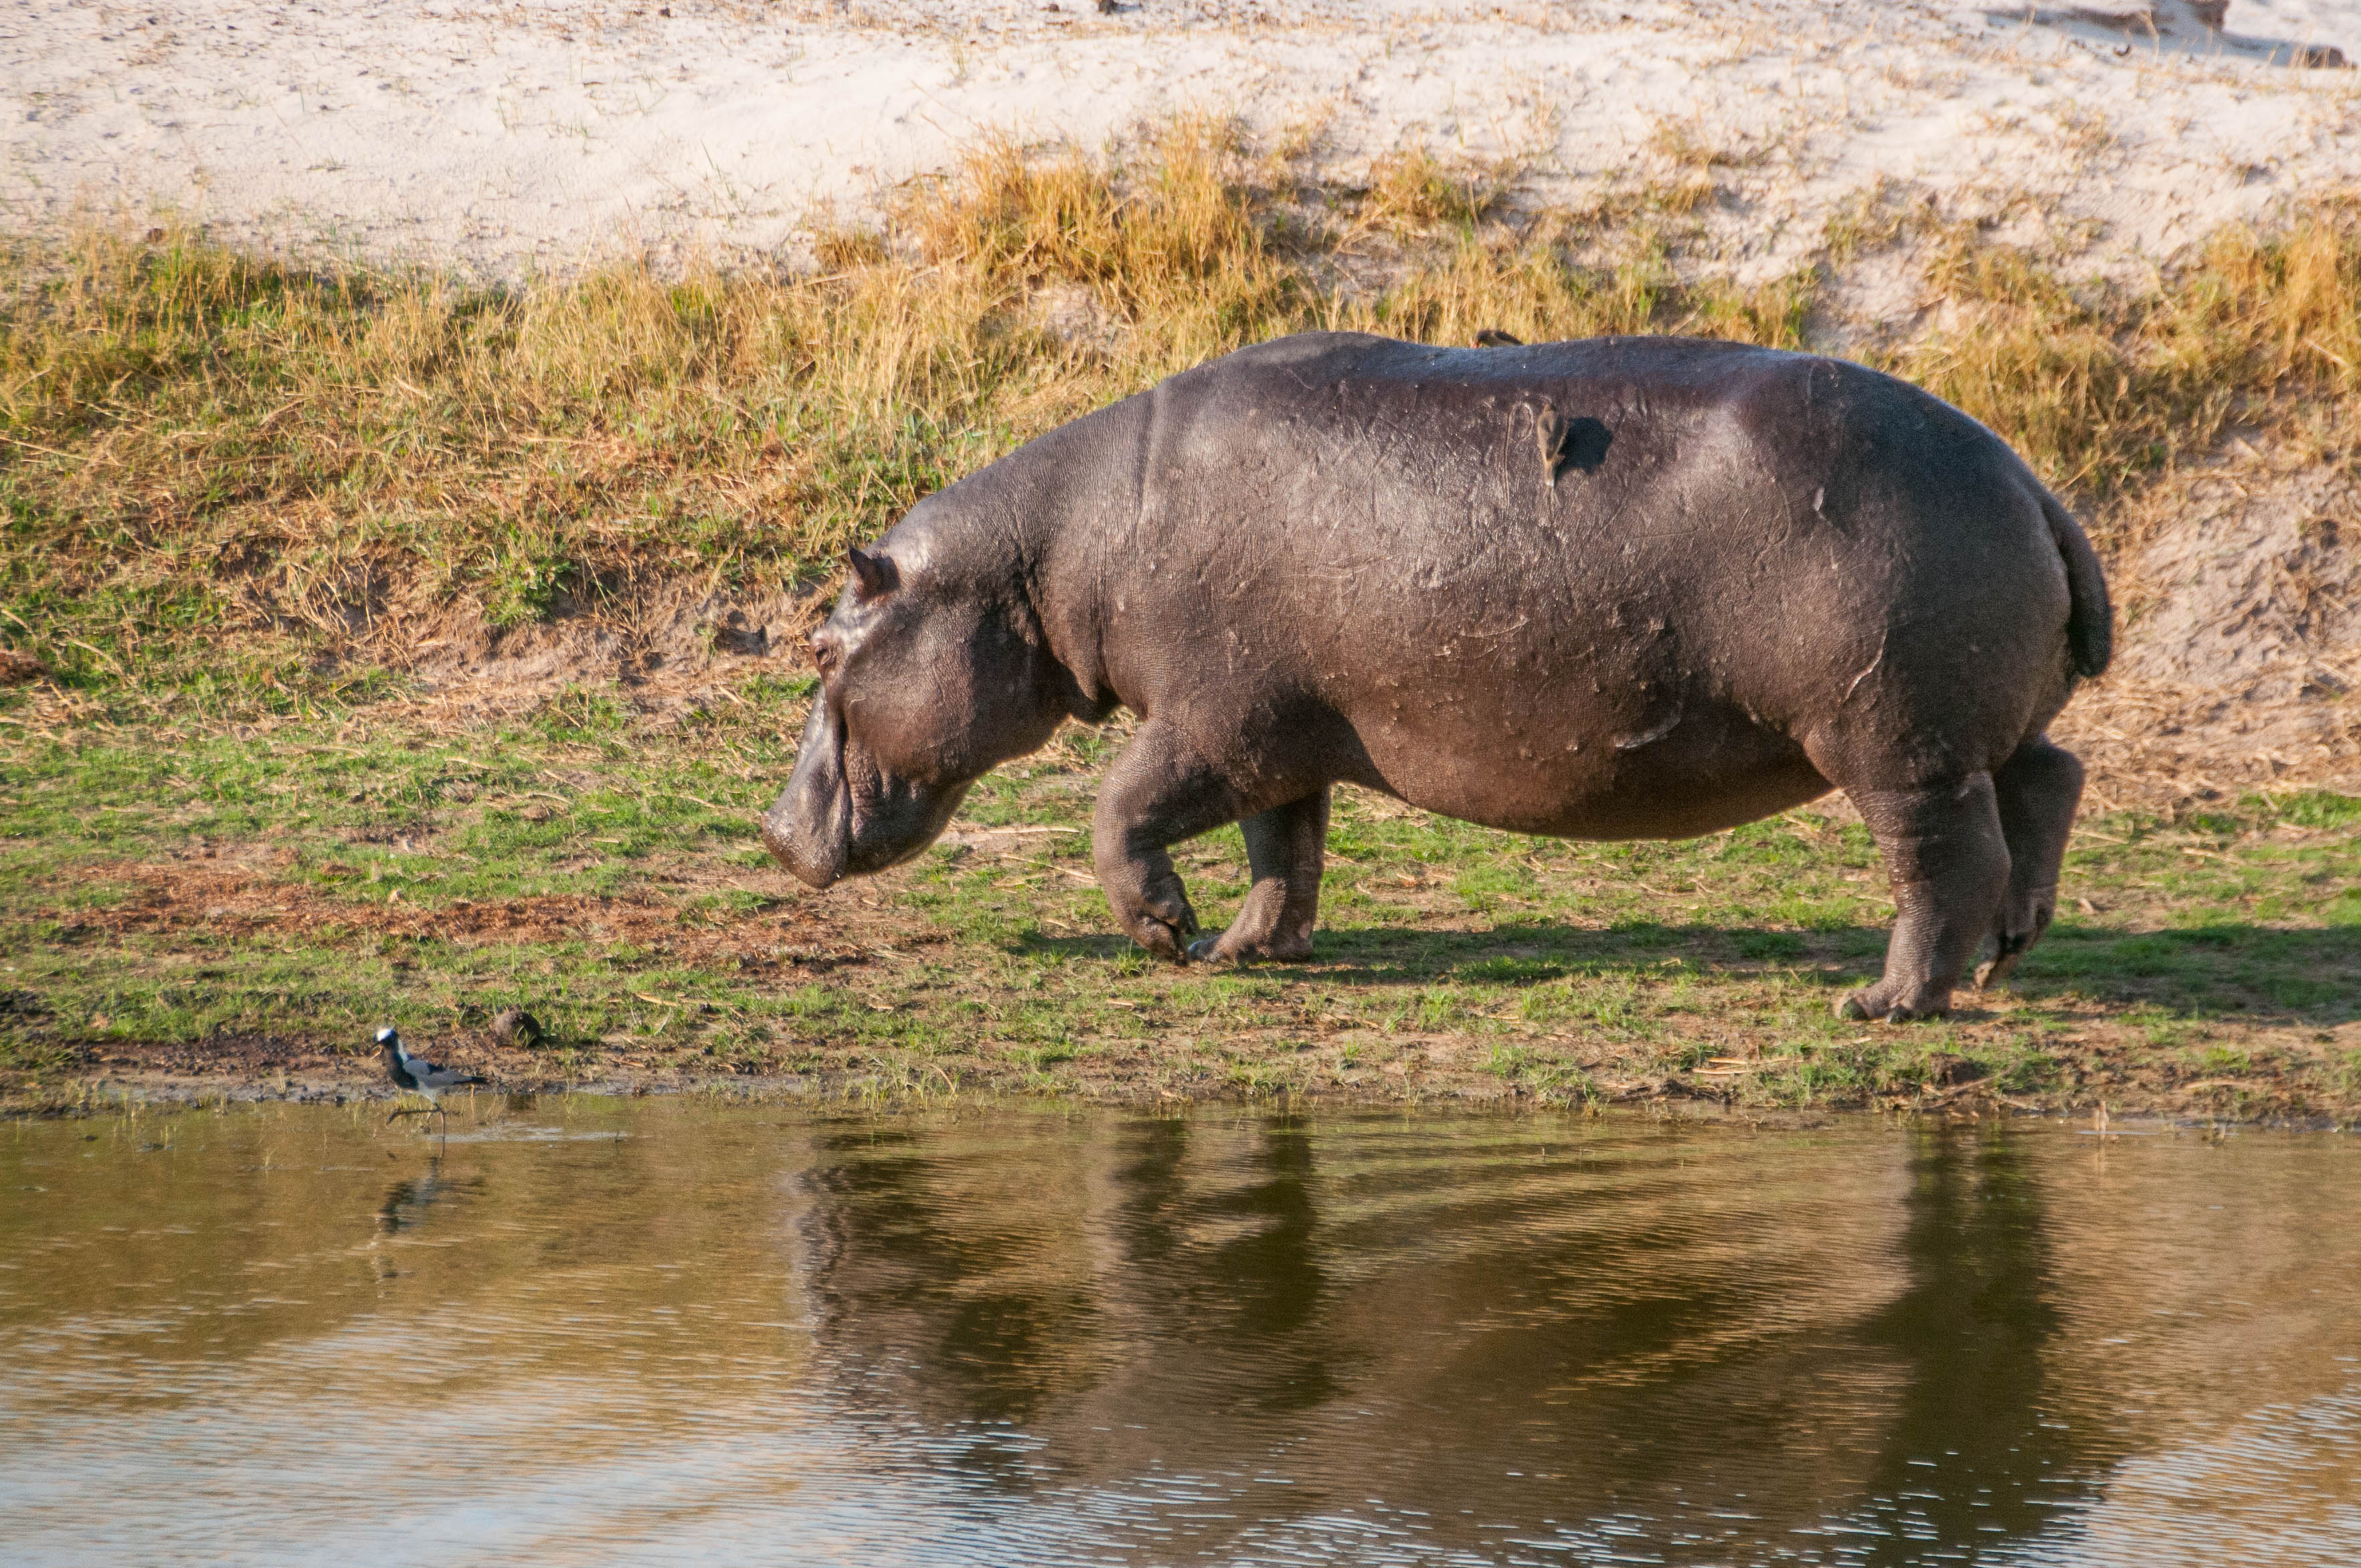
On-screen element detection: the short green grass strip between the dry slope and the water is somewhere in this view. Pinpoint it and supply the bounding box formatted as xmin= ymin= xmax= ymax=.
xmin=0 ymin=697 xmax=2361 ymax=1108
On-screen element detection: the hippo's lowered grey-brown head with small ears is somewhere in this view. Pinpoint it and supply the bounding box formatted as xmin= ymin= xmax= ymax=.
xmin=763 ymin=536 xmax=1065 ymax=888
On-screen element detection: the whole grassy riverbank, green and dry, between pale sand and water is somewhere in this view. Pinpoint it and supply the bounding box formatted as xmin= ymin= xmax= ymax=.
xmin=0 ymin=64 xmax=2361 ymax=1120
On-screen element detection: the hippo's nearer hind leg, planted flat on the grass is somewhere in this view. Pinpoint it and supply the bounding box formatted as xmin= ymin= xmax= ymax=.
xmin=1837 ymin=772 xmax=2009 ymax=1020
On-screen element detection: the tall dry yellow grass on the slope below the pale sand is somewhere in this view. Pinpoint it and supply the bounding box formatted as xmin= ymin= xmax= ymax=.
xmin=0 ymin=120 xmax=2361 ymax=713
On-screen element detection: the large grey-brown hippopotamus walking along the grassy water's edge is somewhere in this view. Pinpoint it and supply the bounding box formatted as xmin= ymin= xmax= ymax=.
xmin=763 ymin=333 xmax=2113 ymax=1020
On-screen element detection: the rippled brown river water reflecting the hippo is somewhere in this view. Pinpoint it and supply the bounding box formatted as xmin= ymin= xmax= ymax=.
xmin=0 ymin=1098 xmax=2361 ymax=1568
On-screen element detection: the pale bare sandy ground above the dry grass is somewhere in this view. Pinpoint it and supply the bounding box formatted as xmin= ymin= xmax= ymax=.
xmin=0 ymin=0 xmax=2361 ymax=274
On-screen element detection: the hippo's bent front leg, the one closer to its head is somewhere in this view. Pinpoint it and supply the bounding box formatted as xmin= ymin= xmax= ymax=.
xmin=1091 ymin=720 xmax=1239 ymax=964
